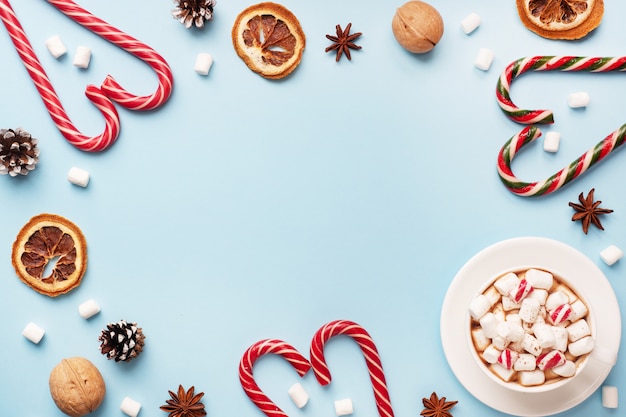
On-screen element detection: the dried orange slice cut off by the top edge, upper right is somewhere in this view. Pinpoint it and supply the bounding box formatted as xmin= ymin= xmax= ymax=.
xmin=516 ymin=0 xmax=604 ymax=40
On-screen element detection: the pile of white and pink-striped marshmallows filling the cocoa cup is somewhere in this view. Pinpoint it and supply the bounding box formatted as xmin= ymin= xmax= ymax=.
xmin=469 ymin=268 xmax=595 ymax=386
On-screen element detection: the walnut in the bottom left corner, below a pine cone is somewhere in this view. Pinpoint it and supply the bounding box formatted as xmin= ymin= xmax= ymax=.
xmin=48 ymin=357 xmax=106 ymax=417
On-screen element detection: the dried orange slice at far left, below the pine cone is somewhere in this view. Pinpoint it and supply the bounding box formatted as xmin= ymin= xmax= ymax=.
xmin=11 ymin=213 xmax=87 ymax=297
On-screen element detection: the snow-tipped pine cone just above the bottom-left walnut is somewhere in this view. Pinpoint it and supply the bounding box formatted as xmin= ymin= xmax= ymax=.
xmin=98 ymin=320 xmax=145 ymax=362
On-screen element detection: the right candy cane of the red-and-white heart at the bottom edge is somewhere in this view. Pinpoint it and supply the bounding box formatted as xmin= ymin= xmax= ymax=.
xmin=311 ymin=320 xmax=393 ymax=417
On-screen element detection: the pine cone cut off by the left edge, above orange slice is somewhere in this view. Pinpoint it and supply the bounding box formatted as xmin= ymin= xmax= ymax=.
xmin=0 ymin=127 xmax=39 ymax=177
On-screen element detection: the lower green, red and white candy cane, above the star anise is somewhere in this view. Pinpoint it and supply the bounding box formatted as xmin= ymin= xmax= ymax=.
xmin=498 ymin=124 xmax=626 ymax=197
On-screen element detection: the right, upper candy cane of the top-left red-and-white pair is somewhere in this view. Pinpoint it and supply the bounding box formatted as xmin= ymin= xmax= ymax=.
xmin=47 ymin=0 xmax=174 ymax=110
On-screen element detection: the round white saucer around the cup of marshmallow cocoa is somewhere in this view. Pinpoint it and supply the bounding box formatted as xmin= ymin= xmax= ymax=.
xmin=441 ymin=237 xmax=622 ymax=417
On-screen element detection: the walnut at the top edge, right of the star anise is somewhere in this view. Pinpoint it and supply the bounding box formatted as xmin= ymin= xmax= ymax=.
xmin=391 ymin=0 xmax=443 ymax=54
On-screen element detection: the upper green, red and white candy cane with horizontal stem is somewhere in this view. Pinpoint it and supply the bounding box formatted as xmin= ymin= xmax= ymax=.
xmin=496 ymin=56 xmax=626 ymax=124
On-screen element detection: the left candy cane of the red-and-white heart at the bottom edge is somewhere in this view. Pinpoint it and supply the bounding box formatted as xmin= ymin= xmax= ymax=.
xmin=239 ymin=339 xmax=311 ymax=417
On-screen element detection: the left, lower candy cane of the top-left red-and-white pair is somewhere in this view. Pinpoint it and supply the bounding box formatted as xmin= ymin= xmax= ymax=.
xmin=0 ymin=0 xmax=120 ymax=152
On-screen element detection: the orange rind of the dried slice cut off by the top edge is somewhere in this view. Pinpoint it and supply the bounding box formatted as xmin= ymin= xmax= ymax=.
xmin=516 ymin=0 xmax=604 ymax=40
